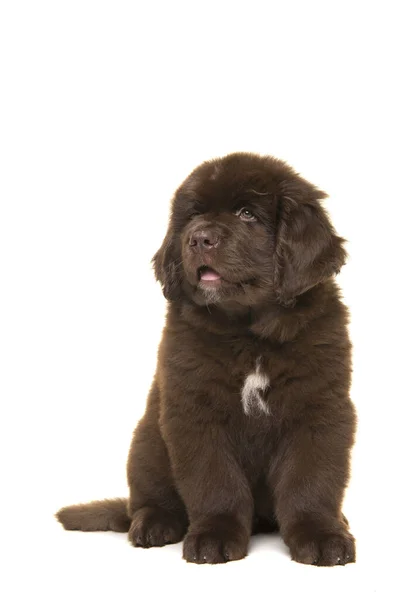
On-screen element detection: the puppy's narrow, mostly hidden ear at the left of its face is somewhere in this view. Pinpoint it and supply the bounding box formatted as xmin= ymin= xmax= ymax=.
xmin=152 ymin=224 xmax=182 ymax=300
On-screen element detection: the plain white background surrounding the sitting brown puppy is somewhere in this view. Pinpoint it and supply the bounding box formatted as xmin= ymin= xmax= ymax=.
xmin=0 ymin=0 xmax=400 ymax=599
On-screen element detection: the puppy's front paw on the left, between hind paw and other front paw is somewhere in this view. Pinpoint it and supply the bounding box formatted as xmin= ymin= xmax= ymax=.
xmin=183 ymin=517 xmax=249 ymax=564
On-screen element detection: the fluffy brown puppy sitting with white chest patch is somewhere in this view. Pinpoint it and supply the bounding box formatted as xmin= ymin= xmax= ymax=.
xmin=57 ymin=154 xmax=355 ymax=565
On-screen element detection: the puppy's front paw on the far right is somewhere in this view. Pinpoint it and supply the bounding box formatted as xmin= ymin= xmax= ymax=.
xmin=288 ymin=524 xmax=356 ymax=567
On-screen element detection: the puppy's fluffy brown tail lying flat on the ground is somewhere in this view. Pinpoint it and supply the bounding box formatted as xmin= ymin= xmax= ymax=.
xmin=55 ymin=498 xmax=131 ymax=532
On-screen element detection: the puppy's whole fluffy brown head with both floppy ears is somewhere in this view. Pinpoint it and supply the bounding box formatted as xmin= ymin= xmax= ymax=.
xmin=154 ymin=154 xmax=345 ymax=307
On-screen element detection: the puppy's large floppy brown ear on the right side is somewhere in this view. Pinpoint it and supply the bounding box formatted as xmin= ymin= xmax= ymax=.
xmin=274 ymin=177 xmax=346 ymax=306
